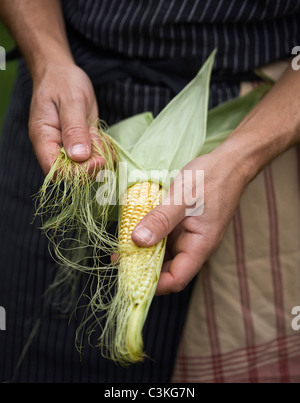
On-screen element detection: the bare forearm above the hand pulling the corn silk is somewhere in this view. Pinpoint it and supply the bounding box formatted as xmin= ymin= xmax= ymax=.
xmin=0 ymin=0 xmax=73 ymax=78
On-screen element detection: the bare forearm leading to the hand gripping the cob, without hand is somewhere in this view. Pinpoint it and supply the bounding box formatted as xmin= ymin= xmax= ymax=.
xmin=215 ymin=68 xmax=300 ymax=183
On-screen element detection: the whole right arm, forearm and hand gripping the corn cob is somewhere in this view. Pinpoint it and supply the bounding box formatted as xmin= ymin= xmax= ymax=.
xmin=132 ymin=67 xmax=300 ymax=295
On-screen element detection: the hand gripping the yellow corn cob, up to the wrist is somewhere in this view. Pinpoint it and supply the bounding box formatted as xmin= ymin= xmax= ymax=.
xmin=132 ymin=150 xmax=246 ymax=295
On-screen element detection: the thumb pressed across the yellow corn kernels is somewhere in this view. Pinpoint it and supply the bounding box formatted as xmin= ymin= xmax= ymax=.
xmin=131 ymin=204 xmax=185 ymax=246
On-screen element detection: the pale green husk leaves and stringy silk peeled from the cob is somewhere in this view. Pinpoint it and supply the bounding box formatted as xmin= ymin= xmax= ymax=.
xmin=37 ymin=52 xmax=270 ymax=365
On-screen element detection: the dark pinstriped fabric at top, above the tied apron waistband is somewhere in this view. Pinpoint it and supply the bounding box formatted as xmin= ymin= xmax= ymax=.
xmin=63 ymin=0 xmax=300 ymax=68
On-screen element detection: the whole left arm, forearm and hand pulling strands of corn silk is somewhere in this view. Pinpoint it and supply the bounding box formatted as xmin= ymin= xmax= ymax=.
xmin=0 ymin=0 xmax=99 ymax=175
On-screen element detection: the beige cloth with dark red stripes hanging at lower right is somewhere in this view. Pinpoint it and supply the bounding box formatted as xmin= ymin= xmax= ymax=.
xmin=172 ymin=61 xmax=300 ymax=383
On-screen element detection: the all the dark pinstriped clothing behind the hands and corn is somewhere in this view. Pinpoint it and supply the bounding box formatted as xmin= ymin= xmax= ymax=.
xmin=0 ymin=0 xmax=300 ymax=383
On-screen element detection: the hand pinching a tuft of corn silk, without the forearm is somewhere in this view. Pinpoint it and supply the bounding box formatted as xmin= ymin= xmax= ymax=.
xmin=29 ymin=62 xmax=100 ymax=175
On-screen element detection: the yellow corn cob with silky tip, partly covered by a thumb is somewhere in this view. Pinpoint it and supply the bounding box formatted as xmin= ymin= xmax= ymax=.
xmin=102 ymin=182 xmax=165 ymax=364
